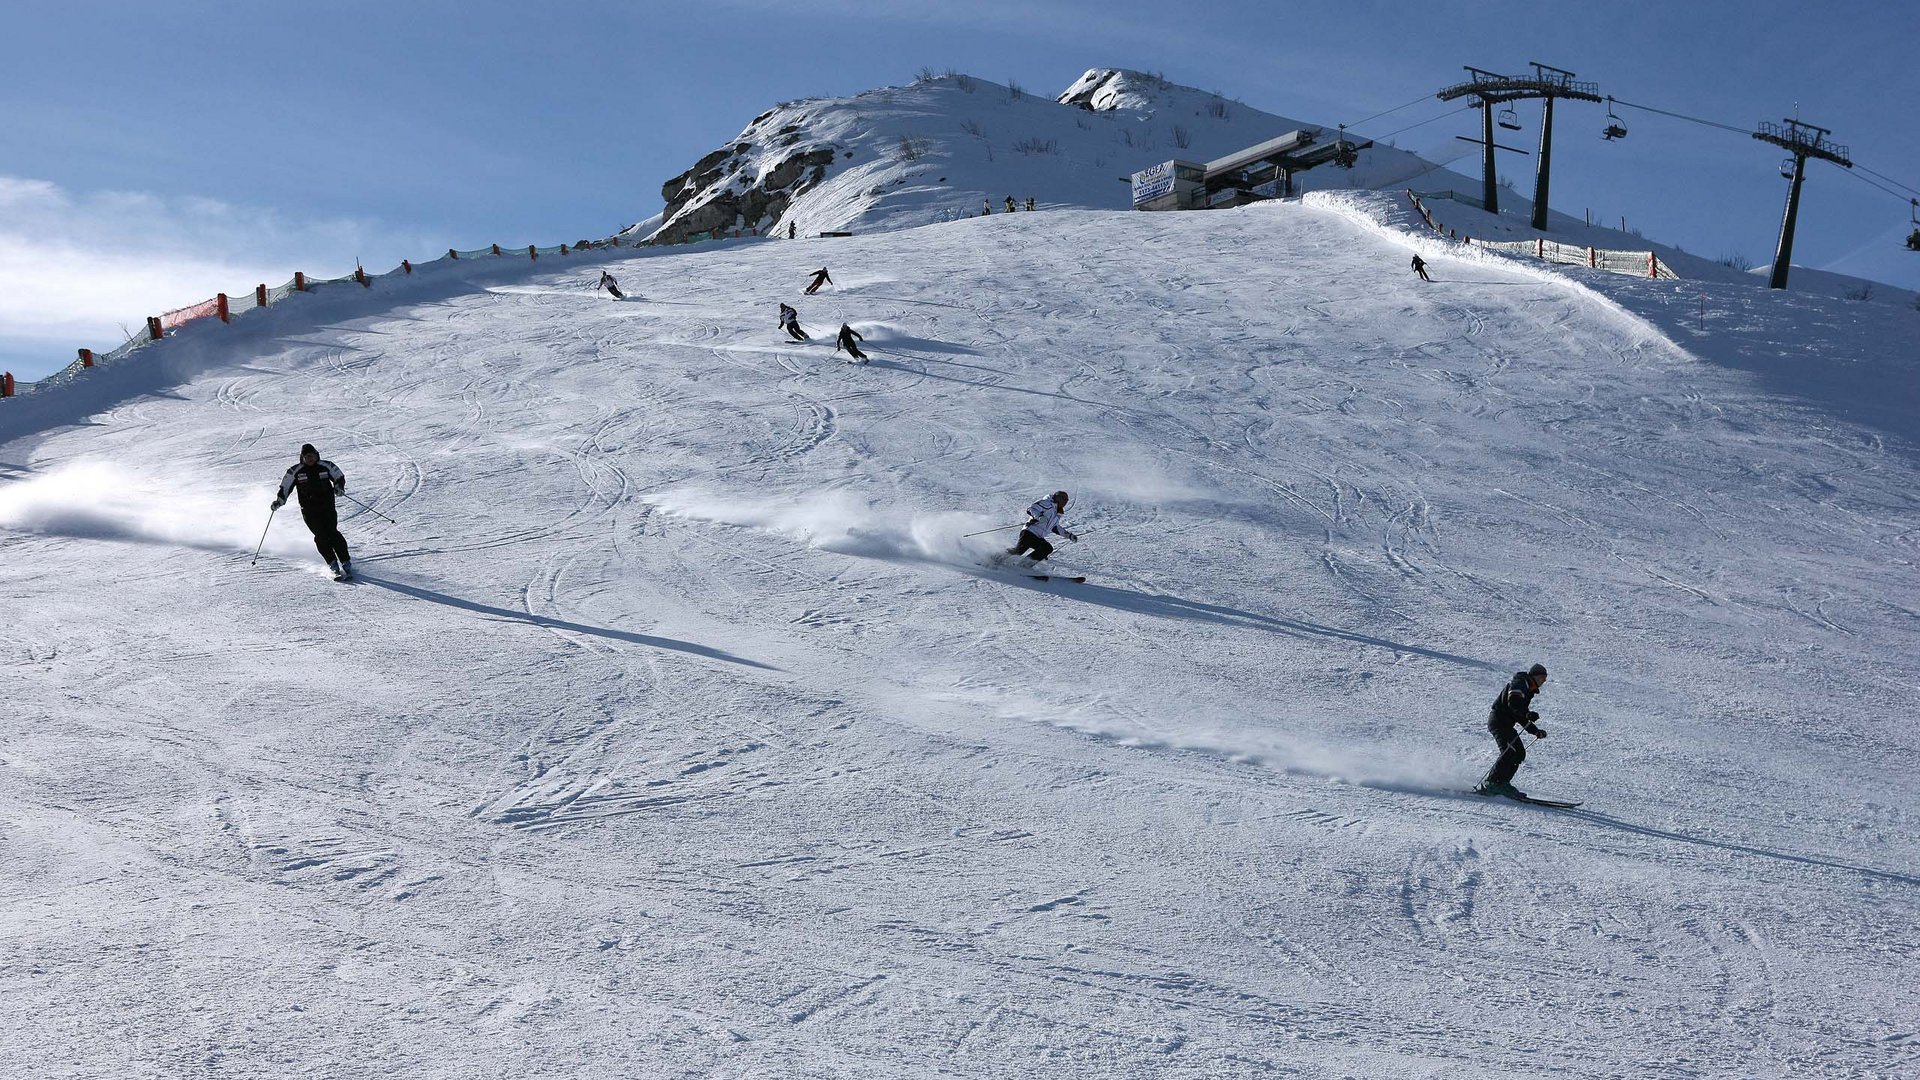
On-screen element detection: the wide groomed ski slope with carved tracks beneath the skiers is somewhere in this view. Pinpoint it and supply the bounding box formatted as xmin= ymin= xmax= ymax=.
xmin=0 ymin=198 xmax=1920 ymax=1080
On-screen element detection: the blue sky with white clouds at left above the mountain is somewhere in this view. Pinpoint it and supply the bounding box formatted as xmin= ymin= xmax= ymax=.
xmin=0 ymin=0 xmax=1920 ymax=377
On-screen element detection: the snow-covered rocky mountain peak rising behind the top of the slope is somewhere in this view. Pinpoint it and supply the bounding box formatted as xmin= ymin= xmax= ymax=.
xmin=630 ymin=67 xmax=1467 ymax=242
